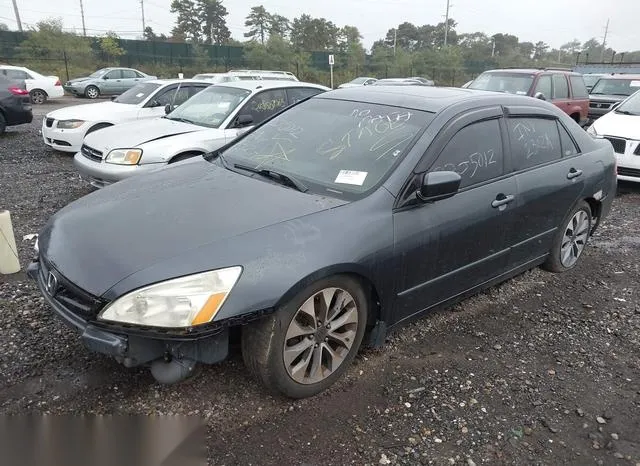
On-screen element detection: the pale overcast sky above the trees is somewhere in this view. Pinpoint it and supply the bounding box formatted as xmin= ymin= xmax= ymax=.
xmin=0 ymin=0 xmax=640 ymax=52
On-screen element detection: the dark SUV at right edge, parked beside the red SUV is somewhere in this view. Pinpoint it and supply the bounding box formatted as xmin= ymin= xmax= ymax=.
xmin=589 ymin=74 xmax=640 ymax=122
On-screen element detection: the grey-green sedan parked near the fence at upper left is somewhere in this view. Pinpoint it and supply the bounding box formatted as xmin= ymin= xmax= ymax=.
xmin=64 ymin=68 xmax=158 ymax=99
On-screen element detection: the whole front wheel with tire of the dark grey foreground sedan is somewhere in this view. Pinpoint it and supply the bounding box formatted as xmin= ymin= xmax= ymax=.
xmin=242 ymin=275 xmax=368 ymax=398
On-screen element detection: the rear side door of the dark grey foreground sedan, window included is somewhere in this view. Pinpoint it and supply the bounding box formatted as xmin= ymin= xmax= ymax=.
xmin=506 ymin=107 xmax=586 ymax=266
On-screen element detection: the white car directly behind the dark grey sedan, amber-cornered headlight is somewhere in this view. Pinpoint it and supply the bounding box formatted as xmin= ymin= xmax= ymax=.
xmin=73 ymin=81 xmax=329 ymax=188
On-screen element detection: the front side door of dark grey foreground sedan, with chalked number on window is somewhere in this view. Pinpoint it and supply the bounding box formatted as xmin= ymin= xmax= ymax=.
xmin=393 ymin=107 xmax=516 ymax=320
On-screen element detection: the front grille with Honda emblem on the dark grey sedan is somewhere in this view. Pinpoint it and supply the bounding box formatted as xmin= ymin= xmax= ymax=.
xmin=38 ymin=258 xmax=103 ymax=320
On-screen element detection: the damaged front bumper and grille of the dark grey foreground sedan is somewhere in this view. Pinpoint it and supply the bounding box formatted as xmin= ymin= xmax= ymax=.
xmin=27 ymin=260 xmax=229 ymax=367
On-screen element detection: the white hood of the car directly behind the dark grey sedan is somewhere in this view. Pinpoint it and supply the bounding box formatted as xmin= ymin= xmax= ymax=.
xmin=84 ymin=118 xmax=207 ymax=152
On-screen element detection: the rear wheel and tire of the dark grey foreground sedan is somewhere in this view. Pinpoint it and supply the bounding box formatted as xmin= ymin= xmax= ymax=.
xmin=543 ymin=201 xmax=592 ymax=273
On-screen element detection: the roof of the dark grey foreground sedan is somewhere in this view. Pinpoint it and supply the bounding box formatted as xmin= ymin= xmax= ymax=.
xmin=314 ymin=86 xmax=549 ymax=113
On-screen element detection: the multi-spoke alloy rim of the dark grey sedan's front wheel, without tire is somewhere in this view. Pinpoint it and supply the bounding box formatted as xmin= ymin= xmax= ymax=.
xmin=283 ymin=288 xmax=358 ymax=384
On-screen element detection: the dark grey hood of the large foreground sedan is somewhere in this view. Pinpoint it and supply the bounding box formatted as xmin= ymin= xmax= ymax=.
xmin=38 ymin=158 xmax=346 ymax=296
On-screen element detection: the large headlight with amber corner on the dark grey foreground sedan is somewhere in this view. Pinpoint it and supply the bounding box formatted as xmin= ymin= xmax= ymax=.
xmin=98 ymin=266 xmax=242 ymax=328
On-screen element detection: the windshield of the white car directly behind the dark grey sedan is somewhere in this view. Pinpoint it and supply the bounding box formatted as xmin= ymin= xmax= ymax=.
xmin=166 ymin=86 xmax=251 ymax=128
